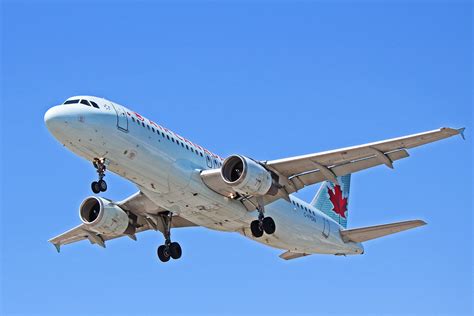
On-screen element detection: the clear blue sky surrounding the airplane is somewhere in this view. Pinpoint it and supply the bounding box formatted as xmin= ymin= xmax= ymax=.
xmin=0 ymin=1 xmax=473 ymax=315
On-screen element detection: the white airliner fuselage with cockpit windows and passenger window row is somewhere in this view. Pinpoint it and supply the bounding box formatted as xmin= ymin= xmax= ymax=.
xmin=45 ymin=96 xmax=363 ymax=254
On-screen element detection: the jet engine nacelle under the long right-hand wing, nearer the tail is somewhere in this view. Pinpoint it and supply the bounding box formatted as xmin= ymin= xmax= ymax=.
xmin=221 ymin=155 xmax=278 ymax=195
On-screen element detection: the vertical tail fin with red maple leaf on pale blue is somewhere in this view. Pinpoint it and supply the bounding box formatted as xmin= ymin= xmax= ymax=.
xmin=311 ymin=174 xmax=351 ymax=228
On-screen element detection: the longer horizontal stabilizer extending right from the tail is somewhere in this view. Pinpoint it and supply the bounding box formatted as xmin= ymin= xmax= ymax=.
xmin=341 ymin=220 xmax=426 ymax=242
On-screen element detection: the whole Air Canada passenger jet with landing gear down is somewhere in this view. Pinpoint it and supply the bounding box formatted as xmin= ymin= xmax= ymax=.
xmin=44 ymin=95 xmax=464 ymax=262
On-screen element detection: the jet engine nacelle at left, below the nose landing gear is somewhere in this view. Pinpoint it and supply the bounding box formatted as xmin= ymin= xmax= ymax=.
xmin=79 ymin=196 xmax=133 ymax=235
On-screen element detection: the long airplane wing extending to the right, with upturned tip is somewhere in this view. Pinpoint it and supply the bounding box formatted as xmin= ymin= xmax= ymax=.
xmin=201 ymin=127 xmax=464 ymax=211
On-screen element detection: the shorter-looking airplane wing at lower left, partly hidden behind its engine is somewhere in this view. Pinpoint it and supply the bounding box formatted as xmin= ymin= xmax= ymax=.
xmin=49 ymin=191 xmax=197 ymax=252
